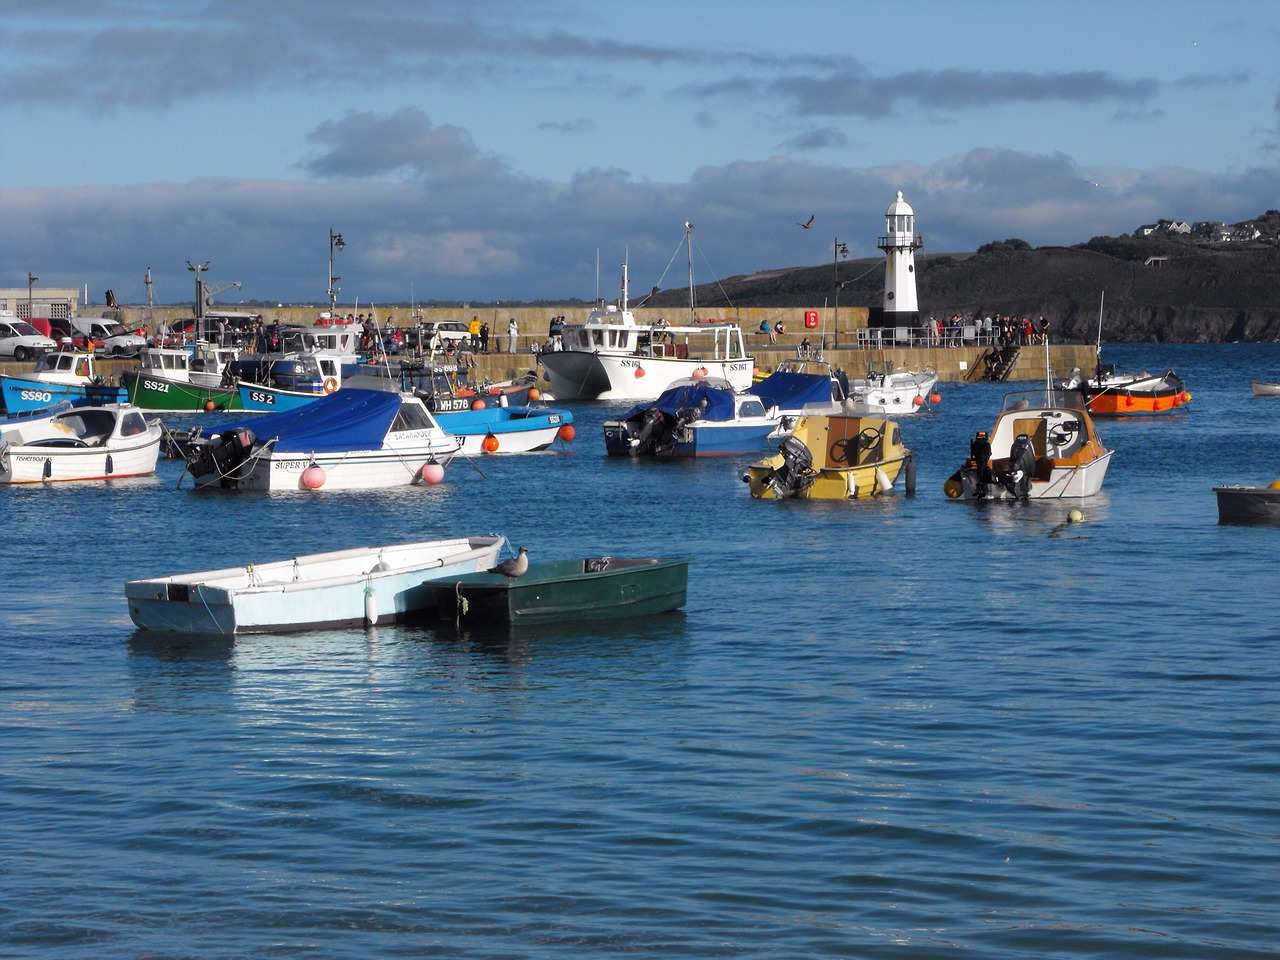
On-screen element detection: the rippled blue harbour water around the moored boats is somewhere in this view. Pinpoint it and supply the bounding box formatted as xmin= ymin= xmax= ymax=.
xmin=0 ymin=344 xmax=1280 ymax=959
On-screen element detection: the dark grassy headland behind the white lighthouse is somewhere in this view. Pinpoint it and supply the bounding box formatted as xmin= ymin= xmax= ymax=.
xmin=646 ymin=224 xmax=1280 ymax=343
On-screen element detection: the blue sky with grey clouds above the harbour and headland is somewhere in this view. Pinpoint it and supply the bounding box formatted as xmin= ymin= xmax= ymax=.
xmin=0 ymin=0 xmax=1280 ymax=307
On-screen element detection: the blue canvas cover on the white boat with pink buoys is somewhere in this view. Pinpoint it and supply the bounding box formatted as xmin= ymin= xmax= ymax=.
xmin=219 ymin=387 xmax=401 ymax=453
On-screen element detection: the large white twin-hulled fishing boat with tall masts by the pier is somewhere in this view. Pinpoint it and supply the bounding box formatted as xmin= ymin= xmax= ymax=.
xmin=538 ymin=223 xmax=755 ymax=402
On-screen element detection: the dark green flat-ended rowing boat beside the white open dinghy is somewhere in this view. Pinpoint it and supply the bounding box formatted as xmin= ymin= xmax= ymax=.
xmin=430 ymin=557 xmax=691 ymax=625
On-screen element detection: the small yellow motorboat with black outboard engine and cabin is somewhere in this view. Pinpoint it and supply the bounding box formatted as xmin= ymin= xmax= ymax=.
xmin=742 ymin=413 xmax=915 ymax=500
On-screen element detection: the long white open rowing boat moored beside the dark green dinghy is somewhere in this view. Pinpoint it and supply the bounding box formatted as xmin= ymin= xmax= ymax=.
xmin=124 ymin=536 xmax=506 ymax=636
